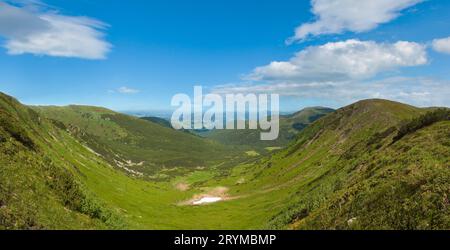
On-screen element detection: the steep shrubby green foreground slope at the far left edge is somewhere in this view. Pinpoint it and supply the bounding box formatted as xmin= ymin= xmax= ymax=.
xmin=0 ymin=93 xmax=121 ymax=229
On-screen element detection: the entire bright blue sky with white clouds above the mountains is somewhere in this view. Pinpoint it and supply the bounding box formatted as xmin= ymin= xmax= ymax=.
xmin=0 ymin=0 xmax=450 ymax=111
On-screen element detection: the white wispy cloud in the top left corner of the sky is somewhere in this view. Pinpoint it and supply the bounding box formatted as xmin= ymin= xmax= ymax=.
xmin=0 ymin=0 xmax=111 ymax=59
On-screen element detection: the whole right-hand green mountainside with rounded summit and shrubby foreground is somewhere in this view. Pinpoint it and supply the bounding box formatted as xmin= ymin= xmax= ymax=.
xmin=227 ymin=100 xmax=450 ymax=229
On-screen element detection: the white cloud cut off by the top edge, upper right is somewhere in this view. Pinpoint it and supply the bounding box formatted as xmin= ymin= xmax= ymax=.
xmin=287 ymin=0 xmax=423 ymax=43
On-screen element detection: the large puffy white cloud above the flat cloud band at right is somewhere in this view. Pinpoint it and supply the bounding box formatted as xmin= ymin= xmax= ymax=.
xmin=248 ymin=40 xmax=428 ymax=83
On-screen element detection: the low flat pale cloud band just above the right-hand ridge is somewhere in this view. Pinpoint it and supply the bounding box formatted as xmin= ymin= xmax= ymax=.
xmin=212 ymin=77 xmax=450 ymax=107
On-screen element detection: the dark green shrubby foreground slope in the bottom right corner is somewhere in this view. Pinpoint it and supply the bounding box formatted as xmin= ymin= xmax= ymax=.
xmin=292 ymin=118 xmax=450 ymax=230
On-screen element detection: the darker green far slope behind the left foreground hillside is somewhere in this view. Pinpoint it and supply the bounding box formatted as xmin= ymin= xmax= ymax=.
xmin=33 ymin=106 xmax=245 ymax=178
